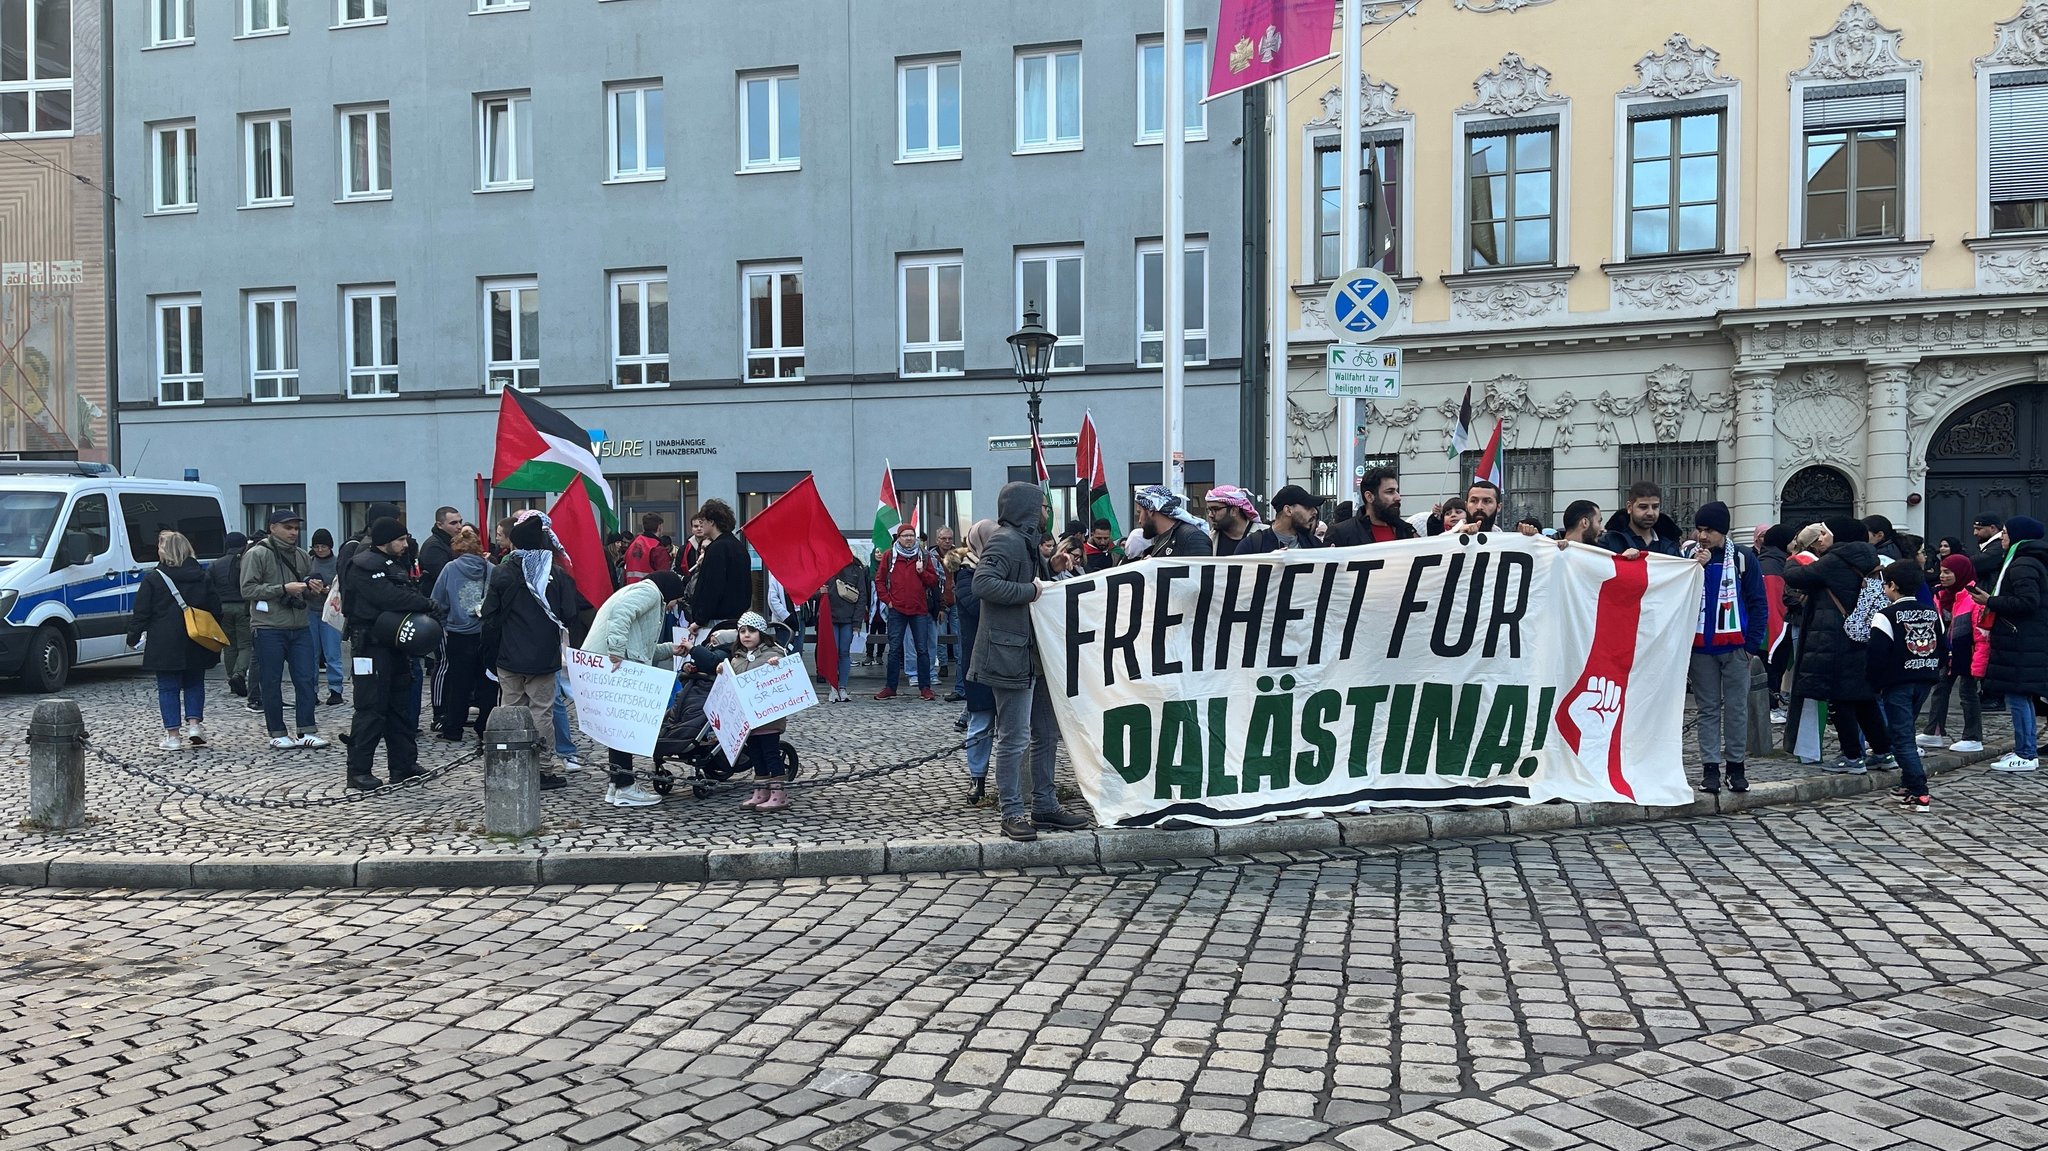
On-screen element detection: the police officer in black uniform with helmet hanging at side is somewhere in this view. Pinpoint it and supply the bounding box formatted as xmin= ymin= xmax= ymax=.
xmin=346 ymin=518 xmax=438 ymax=791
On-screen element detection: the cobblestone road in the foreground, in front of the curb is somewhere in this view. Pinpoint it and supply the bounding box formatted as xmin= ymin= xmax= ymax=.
xmin=0 ymin=757 xmax=2048 ymax=1151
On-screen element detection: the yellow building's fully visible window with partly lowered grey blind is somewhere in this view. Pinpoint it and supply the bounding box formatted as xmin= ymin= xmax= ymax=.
xmin=1800 ymin=80 xmax=1907 ymax=244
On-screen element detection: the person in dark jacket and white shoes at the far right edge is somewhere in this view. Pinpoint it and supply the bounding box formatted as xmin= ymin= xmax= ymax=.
xmin=1985 ymin=516 xmax=2048 ymax=772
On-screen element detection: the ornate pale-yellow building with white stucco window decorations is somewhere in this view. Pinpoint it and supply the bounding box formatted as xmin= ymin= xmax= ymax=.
xmin=1286 ymin=0 xmax=2048 ymax=537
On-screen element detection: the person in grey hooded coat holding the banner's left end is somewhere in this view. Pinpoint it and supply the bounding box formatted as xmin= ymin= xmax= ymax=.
xmin=967 ymin=481 xmax=1089 ymax=842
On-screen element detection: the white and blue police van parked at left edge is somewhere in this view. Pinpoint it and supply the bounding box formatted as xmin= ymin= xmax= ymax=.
xmin=0 ymin=459 xmax=227 ymax=692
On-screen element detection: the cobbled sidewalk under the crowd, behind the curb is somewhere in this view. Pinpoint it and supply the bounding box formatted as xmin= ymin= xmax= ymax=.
xmin=0 ymin=670 xmax=2011 ymax=856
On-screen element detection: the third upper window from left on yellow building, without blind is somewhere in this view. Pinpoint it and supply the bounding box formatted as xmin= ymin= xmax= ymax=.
xmin=1628 ymin=100 xmax=1726 ymax=260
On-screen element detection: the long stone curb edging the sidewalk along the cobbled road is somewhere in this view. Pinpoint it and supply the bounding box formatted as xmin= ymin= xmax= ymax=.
xmin=0 ymin=750 xmax=2001 ymax=891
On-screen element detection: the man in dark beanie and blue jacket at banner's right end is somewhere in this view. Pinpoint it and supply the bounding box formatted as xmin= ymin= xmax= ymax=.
xmin=1692 ymin=502 xmax=1772 ymax=793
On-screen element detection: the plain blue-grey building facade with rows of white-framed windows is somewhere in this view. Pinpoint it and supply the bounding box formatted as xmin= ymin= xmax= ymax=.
xmin=109 ymin=0 xmax=1243 ymax=535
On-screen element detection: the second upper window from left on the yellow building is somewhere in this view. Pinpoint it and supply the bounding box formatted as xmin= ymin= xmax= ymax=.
xmin=1464 ymin=125 xmax=1556 ymax=272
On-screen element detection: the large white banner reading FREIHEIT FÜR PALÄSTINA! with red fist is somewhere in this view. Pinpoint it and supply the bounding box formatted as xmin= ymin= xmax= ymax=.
xmin=1032 ymin=532 xmax=1700 ymax=827
